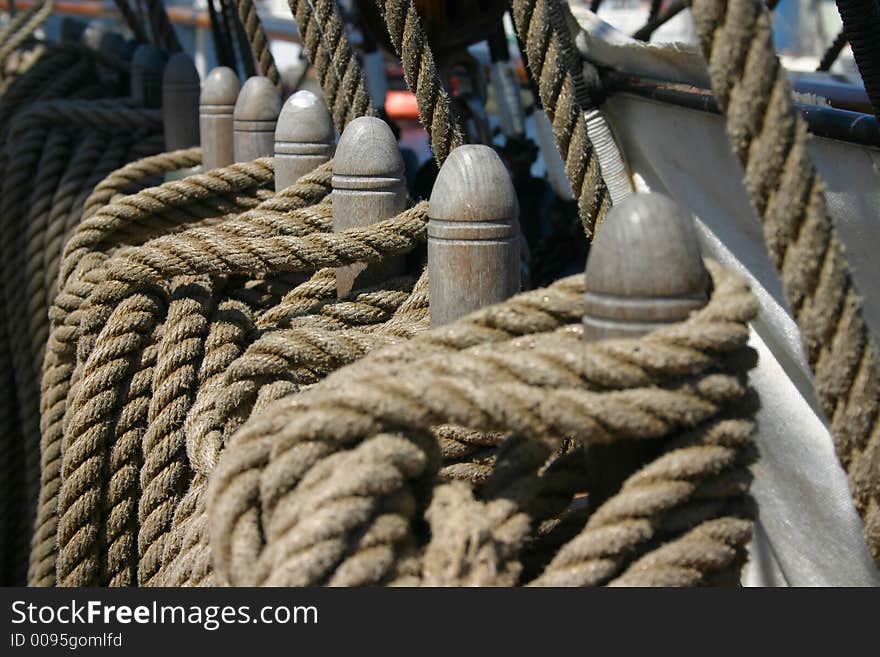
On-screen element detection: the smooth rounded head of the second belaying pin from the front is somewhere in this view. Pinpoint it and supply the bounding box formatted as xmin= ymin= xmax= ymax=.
xmin=428 ymin=144 xmax=519 ymax=224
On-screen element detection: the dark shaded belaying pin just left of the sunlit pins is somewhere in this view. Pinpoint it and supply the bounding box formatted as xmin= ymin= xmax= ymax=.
xmin=162 ymin=52 xmax=200 ymax=151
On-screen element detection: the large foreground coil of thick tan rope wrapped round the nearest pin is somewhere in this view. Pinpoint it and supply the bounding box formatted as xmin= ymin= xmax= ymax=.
xmin=207 ymin=187 xmax=756 ymax=585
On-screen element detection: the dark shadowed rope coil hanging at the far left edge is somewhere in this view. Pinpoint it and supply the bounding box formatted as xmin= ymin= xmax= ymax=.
xmin=0 ymin=36 xmax=168 ymax=583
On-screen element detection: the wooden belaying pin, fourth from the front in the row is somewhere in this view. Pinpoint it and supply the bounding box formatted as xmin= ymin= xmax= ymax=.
xmin=275 ymin=90 xmax=336 ymax=192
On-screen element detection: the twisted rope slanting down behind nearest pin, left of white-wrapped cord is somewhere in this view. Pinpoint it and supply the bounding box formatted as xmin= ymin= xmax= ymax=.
xmin=511 ymin=0 xmax=610 ymax=239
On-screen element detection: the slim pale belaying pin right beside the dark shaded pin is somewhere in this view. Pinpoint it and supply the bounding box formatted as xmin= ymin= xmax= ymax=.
xmin=199 ymin=66 xmax=241 ymax=171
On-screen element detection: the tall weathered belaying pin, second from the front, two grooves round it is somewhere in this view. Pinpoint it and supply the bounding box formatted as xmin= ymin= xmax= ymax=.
xmin=428 ymin=145 xmax=520 ymax=326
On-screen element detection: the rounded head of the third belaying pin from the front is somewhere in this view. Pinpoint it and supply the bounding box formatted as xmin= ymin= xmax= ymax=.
xmin=333 ymin=116 xmax=404 ymax=179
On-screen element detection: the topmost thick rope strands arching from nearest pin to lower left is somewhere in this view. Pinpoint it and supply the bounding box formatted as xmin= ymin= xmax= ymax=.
xmin=208 ymin=262 xmax=754 ymax=583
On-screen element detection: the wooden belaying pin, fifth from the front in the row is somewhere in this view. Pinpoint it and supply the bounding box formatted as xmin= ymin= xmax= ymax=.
xmin=232 ymin=75 xmax=281 ymax=162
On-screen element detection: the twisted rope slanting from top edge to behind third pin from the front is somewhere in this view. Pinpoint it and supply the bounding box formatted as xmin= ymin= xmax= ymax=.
xmin=288 ymin=0 xmax=375 ymax=134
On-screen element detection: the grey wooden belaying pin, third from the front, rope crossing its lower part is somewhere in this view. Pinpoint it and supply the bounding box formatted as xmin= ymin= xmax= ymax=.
xmin=333 ymin=116 xmax=406 ymax=298
